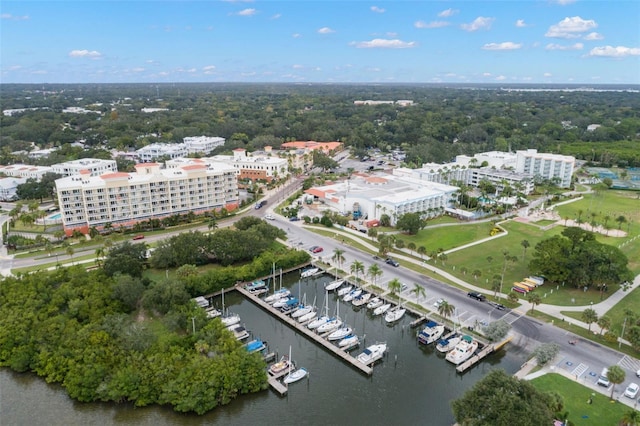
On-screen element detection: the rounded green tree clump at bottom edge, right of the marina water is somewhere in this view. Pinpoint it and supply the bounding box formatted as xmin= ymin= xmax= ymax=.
xmin=452 ymin=370 xmax=562 ymax=426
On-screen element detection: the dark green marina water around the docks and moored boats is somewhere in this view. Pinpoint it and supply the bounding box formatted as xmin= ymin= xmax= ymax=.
xmin=0 ymin=273 xmax=524 ymax=426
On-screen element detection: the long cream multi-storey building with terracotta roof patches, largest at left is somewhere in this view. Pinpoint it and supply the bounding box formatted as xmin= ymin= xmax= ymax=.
xmin=56 ymin=163 xmax=239 ymax=234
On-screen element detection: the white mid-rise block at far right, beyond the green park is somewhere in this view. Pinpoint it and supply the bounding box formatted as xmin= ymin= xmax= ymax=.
xmin=516 ymin=149 xmax=576 ymax=188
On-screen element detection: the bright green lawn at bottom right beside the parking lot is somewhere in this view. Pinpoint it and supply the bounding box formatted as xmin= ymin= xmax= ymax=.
xmin=531 ymin=373 xmax=631 ymax=426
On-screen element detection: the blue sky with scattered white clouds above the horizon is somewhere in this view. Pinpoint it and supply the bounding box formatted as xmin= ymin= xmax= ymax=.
xmin=0 ymin=0 xmax=640 ymax=84
